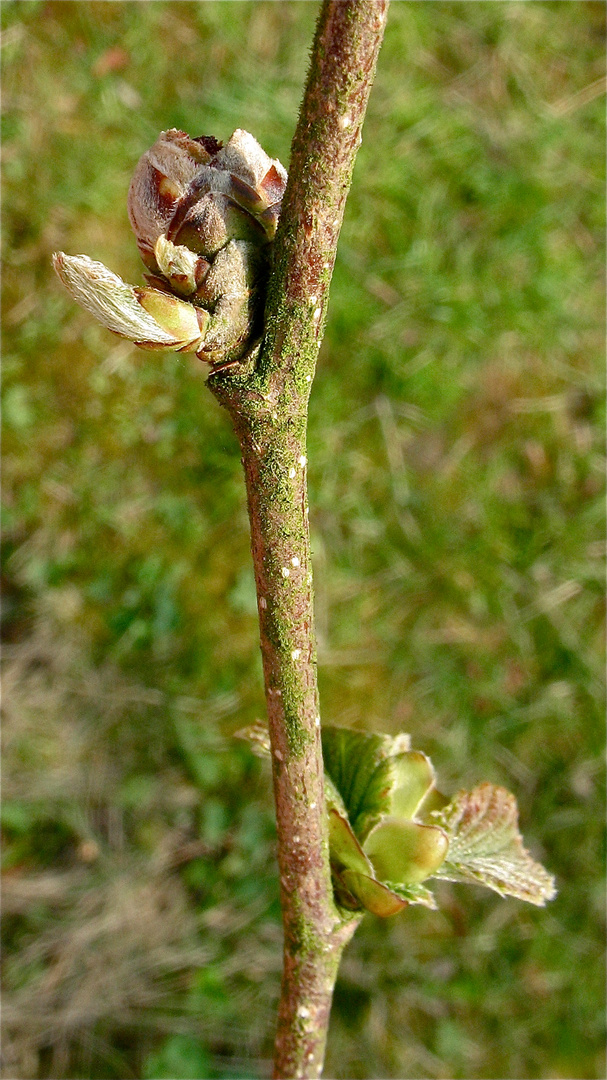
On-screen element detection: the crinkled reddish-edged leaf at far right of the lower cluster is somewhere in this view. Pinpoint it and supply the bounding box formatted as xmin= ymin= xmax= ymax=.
xmin=432 ymin=784 xmax=556 ymax=907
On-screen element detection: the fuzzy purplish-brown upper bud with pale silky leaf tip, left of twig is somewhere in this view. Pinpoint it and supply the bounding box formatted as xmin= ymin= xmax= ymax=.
xmin=53 ymin=129 xmax=286 ymax=366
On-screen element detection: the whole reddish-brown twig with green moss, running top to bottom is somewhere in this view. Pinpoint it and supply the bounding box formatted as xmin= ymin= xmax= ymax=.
xmin=208 ymin=0 xmax=388 ymax=1080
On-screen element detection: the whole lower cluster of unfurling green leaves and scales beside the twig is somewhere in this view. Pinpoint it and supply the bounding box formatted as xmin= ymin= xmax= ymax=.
xmin=239 ymin=724 xmax=555 ymax=917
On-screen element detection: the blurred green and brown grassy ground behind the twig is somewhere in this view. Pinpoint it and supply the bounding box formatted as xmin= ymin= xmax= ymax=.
xmin=2 ymin=0 xmax=605 ymax=1080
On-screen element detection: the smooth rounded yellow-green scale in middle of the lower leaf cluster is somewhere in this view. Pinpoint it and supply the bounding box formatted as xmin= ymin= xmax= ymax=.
xmin=364 ymin=818 xmax=449 ymax=885
